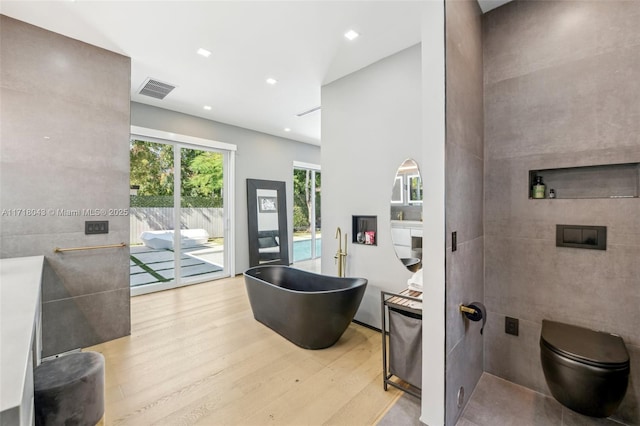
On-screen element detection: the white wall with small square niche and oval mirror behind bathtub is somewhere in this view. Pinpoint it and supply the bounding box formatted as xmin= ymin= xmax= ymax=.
xmin=321 ymin=45 xmax=422 ymax=328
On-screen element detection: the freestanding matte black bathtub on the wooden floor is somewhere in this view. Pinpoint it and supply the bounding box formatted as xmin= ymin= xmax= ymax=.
xmin=244 ymin=265 xmax=367 ymax=349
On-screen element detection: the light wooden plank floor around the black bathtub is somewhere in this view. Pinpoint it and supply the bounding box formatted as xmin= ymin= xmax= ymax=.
xmin=86 ymin=276 xmax=401 ymax=426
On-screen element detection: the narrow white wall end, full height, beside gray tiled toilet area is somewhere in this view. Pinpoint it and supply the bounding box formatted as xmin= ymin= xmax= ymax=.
xmin=420 ymin=1 xmax=446 ymax=426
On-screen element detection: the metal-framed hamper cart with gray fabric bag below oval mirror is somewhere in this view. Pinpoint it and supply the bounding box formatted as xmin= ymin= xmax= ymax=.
xmin=380 ymin=289 xmax=422 ymax=398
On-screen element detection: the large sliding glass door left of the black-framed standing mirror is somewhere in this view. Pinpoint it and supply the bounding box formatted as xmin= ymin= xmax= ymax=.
xmin=130 ymin=131 xmax=233 ymax=295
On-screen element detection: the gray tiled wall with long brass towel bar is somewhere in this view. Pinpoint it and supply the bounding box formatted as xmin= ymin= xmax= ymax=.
xmin=0 ymin=15 xmax=131 ymax=356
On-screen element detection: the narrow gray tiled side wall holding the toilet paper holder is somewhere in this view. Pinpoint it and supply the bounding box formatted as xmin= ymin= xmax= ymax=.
xmin=445 ymin=1 xmax=484 ymax=425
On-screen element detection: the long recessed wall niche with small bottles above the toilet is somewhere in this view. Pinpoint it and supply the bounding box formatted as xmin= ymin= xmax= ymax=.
xmin=529 ymin=163 xmax=640 ymax=199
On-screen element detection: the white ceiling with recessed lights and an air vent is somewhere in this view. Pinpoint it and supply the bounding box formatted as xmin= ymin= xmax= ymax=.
xmin=0 ymin=0 xmax=508 ymax=145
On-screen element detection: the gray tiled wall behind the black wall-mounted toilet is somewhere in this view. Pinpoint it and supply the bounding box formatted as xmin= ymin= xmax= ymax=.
xmin=483 ymin=1 xmax=640 ymax=424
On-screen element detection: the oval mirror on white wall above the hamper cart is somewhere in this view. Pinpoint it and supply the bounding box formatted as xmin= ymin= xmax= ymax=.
xmin=391 ymin=159 xmax=422 ymax=272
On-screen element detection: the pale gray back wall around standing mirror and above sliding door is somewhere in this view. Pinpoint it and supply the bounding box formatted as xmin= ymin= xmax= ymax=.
xmin=131 ymin=102 xmax=320 ymax=273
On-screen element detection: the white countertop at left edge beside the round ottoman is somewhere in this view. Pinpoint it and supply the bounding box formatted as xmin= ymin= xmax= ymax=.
xmin=0 ymin=256 xmax=44 ymax=413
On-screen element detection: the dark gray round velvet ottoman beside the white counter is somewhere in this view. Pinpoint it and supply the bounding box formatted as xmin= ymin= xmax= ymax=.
xmin=33 ymin=352 xmax=104 ymax=426
